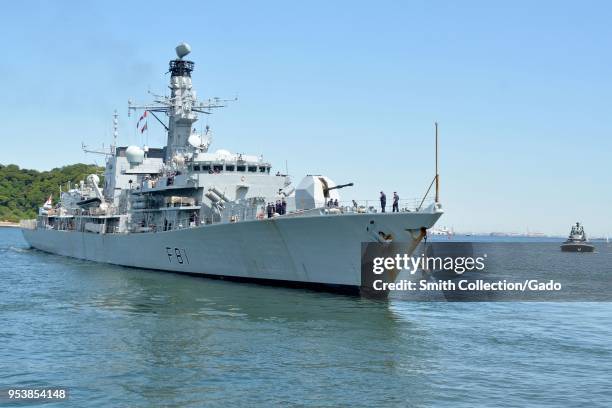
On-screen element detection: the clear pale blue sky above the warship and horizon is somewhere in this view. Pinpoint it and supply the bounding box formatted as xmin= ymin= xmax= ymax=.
xmin=0 ymin=1 xmax=612 ymax=235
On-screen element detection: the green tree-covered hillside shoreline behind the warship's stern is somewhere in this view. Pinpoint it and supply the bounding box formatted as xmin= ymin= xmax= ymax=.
xmin=0 ymin=163 xmax=103 ymax=222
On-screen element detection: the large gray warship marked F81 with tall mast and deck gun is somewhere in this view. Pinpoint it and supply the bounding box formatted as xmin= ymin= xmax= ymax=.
xmin=21 ymin=43 xmax=443 ymax=294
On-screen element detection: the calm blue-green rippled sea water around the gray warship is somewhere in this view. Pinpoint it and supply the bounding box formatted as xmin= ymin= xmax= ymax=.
xmin=0 ymin=228 xmax=612 ymax=407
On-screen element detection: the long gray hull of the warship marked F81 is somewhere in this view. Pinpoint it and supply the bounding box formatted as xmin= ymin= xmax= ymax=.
xmin=22 ymin=213 xmax=441 ymax=291
